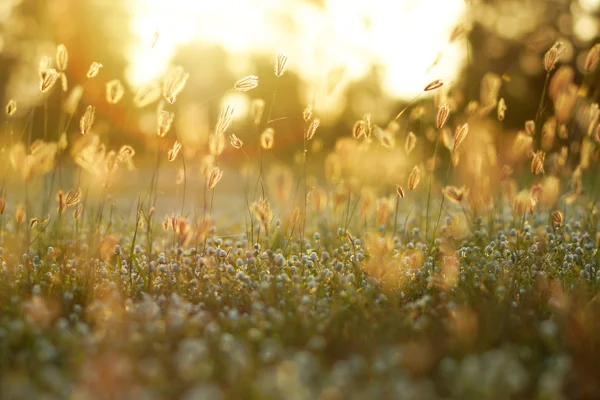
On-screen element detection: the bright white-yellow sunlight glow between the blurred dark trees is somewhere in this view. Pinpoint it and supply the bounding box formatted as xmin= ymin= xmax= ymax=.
xmin=128 ymin=0 xmax=467 ymax=98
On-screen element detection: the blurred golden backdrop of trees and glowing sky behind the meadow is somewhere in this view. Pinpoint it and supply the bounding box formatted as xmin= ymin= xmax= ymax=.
xmin=0 ymin=0 xmax=600 ymax=164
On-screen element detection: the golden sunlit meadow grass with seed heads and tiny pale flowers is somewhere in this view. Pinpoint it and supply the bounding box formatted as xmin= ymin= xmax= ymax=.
xmin=0 ymin=38 xmax=600 ymax=399
